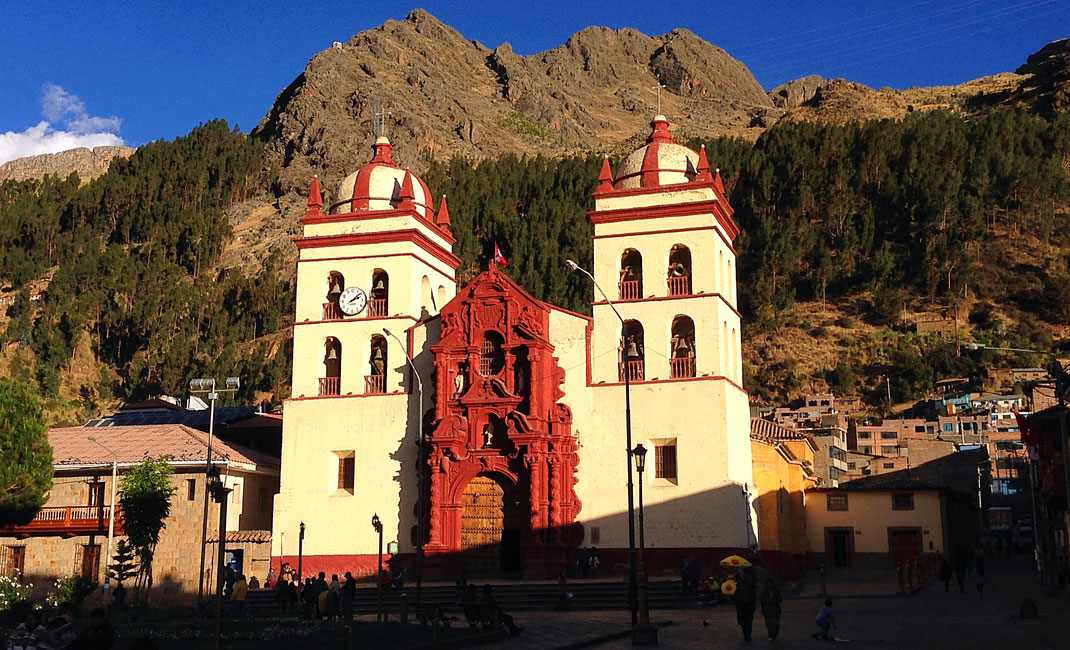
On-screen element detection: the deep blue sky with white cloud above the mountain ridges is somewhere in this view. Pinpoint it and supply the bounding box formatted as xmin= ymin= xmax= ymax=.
xmin=0 ymin=0 xmax=1070 ymax=162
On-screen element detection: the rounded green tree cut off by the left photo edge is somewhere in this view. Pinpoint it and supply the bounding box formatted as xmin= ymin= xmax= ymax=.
xmin=0 ymin=379 xmax=52 ymax=525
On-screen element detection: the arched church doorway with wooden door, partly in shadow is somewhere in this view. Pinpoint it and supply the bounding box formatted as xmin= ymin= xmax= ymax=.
xmin=461 ymin=474 xmax=525 ymax=575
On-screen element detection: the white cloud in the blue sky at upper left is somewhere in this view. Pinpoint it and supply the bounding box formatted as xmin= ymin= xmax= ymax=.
xmin=0 ymin=84 xmax=123 ymax=165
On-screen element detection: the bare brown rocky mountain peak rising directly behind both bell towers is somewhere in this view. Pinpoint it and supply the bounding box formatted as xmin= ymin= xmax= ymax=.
xmin=255 ymin=10 xmax=775 ymax=198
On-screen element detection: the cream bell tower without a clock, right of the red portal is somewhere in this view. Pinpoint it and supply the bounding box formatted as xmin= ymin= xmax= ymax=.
xmin=580 ymin=115 xmax=751 ymax=547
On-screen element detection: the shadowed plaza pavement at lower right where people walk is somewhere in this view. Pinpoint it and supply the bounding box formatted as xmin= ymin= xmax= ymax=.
xmin=482 ymin=556 xmax=1070 ymax=650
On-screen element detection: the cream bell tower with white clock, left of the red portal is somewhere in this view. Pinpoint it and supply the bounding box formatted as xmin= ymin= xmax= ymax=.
xmin=272 ymin=136 xmax=460 ymax=575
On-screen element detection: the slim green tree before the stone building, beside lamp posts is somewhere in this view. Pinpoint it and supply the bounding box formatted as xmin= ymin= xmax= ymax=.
xmin=119 ymin=456 xmax=174 ymax=604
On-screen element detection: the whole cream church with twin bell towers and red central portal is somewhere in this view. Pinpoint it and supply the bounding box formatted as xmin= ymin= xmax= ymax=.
xmin=272 ymin=116 xmax=755 ymax=577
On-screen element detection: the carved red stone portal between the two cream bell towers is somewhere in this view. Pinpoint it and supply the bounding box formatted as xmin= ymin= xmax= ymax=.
xmin=424 ymin=262 xmax=582 ymax=577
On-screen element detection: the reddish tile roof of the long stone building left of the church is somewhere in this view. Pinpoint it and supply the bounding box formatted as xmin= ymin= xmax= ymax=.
xmin=48 ymin=424 xmax=279 ymax=469
